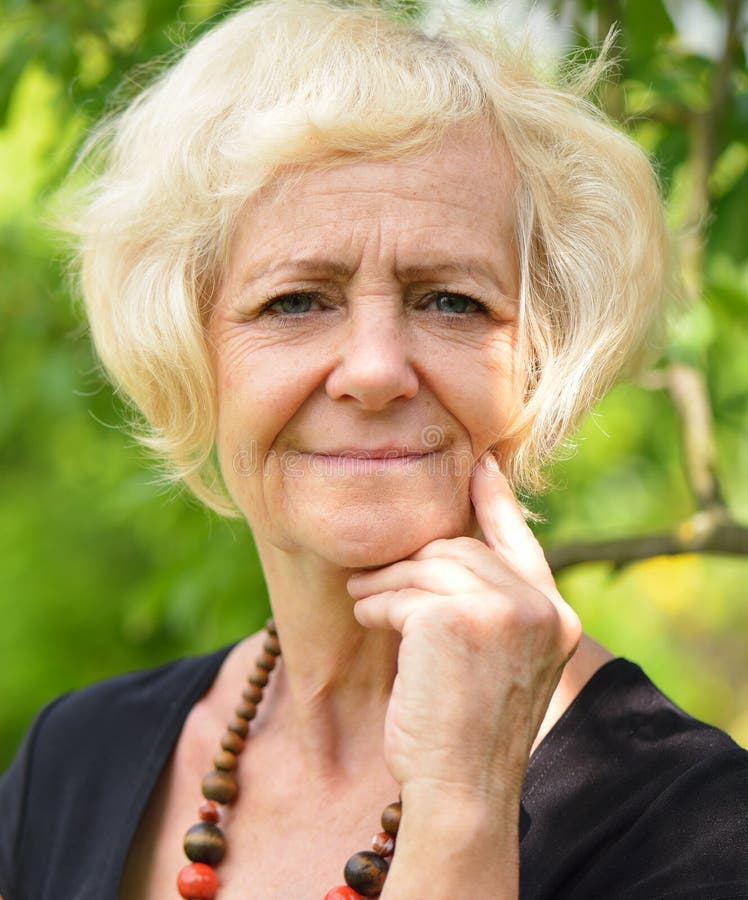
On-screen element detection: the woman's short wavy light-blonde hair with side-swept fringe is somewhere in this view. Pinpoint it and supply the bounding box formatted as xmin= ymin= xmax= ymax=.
xmin=65 ymin=0 xmax=670 ymax=515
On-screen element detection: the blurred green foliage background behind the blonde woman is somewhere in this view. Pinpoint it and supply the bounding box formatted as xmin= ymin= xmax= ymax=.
xmin=0 ymin=0 xmax=748 ymax=767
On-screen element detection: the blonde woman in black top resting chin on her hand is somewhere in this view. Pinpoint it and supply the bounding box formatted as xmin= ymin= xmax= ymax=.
xmin=0 ymin=0 xmax=748 ymax=900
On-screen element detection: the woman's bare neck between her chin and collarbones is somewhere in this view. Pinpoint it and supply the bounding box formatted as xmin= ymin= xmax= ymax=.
xmin=253 ymin=545 xmax=400 ymax=774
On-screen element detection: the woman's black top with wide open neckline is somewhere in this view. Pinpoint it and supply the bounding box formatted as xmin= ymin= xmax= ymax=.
xmin=0 ymin=648 xmax=748 ymax=900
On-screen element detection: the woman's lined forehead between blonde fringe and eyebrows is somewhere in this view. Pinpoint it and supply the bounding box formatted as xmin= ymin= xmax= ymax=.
xmin=231 ymin=126 xmax=515 ymax=282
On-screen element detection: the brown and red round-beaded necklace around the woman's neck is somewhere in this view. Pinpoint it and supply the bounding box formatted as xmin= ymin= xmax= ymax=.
xmin=177 ymin=619 xmax=402 ymax=900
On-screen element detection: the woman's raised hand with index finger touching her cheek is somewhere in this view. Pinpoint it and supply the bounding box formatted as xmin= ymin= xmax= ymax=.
xmin=348 ymin=455 xmax=581 ymax=896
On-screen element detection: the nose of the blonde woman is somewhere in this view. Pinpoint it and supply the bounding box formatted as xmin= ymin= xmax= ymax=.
xmin=326 ymin=298 xmax=418 ymax=412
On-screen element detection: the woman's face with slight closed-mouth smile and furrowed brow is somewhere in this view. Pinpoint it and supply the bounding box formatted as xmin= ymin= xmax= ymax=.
xmin=209 ymin=127 xmax=518 ymax=566
